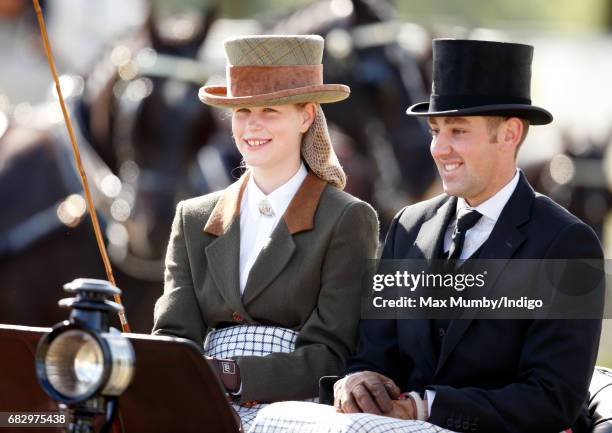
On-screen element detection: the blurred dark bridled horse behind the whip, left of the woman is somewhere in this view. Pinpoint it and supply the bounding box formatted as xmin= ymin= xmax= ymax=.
xmin=0 ymin=6 xmax=231 ymax=332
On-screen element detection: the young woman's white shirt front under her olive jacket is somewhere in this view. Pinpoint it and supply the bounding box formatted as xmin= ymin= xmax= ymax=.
xmin=240 ymin=163 xmax=308 ymax=294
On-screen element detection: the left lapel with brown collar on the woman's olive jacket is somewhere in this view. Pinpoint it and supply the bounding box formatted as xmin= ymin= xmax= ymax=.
xmin=204 ymin=172 xmax=250 ymax=320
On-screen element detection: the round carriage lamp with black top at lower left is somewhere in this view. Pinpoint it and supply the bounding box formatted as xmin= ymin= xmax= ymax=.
xmin=36 ymin=278 xmax=134 ymax=431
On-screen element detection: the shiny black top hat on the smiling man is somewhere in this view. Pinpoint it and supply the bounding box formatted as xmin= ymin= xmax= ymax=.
xmin=406 ymin=39 xmax=553 ymax=125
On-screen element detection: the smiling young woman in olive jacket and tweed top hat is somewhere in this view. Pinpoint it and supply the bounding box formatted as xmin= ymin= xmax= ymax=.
xmin=153 ymin=36 xmax=378 ymax=421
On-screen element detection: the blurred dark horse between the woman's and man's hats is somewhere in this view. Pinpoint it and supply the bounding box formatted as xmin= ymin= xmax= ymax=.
xmin=264 ymin=0 xmax=437 ymax=228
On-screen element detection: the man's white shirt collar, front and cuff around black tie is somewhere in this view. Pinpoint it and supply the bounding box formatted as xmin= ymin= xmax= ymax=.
xmin=425 ymin=169 xmax=519 ymax=416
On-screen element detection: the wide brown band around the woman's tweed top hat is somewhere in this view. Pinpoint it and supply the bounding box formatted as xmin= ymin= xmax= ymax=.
xmin=227 ymin=64 xmax=323 ymax=97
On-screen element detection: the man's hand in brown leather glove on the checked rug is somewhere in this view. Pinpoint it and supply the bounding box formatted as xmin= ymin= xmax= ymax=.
xmin=334 ymin=371 xmax=401 ymax=415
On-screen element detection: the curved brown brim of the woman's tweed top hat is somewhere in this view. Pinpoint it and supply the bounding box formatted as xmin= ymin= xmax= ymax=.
xmin=198 ymin=84 xmax=351 ymax=108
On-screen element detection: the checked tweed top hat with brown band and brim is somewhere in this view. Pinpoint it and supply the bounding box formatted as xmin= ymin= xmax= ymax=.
xmin=199 ymin=35 xmax=350 ymax=107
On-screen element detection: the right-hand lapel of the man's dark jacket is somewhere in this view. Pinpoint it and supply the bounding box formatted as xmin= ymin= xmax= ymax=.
xmin=436 ymin=171 xmax=535 ymax=372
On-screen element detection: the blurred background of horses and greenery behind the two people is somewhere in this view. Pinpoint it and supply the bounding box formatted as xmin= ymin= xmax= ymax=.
xmin=0 ymin=0 xmax=612 ymax=367
